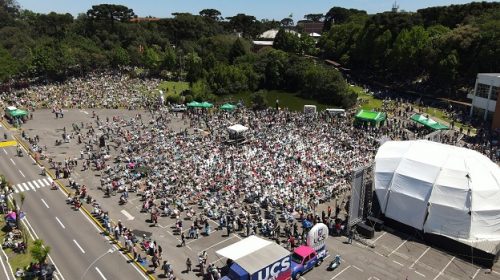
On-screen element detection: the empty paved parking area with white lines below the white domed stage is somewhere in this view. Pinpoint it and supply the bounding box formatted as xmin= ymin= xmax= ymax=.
xmin=316 ymin=229 xmax=500 ymax=280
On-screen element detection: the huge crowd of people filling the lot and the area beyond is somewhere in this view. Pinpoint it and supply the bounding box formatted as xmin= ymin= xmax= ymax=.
xmin=2 ymin=72 xmax=498 ymax=278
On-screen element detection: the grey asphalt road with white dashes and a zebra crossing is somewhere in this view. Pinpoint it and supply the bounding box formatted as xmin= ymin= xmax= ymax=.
xmin=0 ymin=123 xmax=147 ymax=280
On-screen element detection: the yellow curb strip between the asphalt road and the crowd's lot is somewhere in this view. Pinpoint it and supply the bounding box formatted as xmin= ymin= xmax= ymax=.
xmin=13 ymin=135 xmax=156 ymax=280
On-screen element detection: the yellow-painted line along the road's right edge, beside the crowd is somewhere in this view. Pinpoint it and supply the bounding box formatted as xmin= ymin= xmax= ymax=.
xmin=14 ymin=135 xmax=156 ymax=280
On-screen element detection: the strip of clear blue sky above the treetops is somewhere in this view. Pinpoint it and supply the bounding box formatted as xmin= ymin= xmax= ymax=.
xmin=18 ymin=0 xmax=493 ymax=20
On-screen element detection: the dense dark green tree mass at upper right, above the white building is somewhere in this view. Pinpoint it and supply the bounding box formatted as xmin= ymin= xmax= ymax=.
xmin=319 ymin=2 xmax=500 ymax=97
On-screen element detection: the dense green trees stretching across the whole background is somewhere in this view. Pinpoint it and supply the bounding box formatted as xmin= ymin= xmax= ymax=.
xmin=0 ymin=0 xmax=500 ymax=107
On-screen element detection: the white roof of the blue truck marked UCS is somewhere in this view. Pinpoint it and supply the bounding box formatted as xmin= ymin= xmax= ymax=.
xmin=215 ymin=235 xmax=290 ymax=275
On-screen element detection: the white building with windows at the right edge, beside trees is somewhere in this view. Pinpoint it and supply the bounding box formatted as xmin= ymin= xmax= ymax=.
xmin=467 ymin=73 xmax=500 ymax=127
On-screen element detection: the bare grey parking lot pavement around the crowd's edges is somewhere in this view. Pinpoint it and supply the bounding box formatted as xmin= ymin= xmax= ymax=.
xmin=20 ymin=110 xmax=500 ymax=280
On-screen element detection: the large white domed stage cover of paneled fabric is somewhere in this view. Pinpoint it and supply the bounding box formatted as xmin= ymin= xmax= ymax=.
xmin=375 ymin=140 xmax=500 ymax=251
